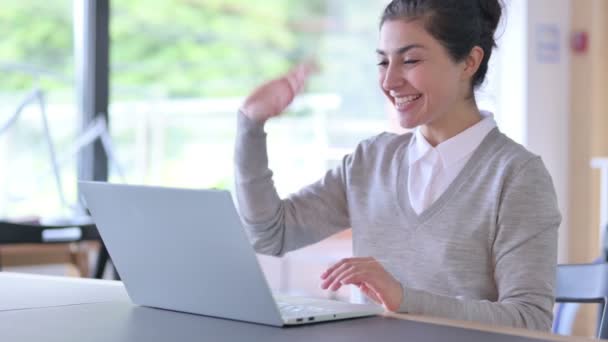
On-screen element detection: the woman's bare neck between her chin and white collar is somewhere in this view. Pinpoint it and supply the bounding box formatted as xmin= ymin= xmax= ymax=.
xmin=420 ymin=102 xmax=482 ymax=147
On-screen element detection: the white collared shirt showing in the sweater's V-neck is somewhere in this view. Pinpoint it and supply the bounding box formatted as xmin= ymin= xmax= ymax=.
xmin=407 ymin=111 xmax=496 ymax=215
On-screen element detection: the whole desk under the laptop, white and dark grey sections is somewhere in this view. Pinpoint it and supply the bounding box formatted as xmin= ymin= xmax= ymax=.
xmin=0 ymin=273 xmax=590 ymax=342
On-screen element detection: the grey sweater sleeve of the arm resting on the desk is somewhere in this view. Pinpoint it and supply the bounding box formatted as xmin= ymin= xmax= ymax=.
xmin=399 ymin=157 xmax=561 ymax=331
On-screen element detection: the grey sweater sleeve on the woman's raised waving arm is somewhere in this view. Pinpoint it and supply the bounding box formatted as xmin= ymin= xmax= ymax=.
xmin=235 ymin=112 xmax=351 ymax=256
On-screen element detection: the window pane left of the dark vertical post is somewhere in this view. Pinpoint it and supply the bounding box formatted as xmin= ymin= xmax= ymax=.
xmin=0 ymin=0 xmax=78 ymax=218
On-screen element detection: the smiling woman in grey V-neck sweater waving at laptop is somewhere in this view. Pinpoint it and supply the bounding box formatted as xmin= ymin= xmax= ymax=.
xmin=236 ymin=0 xmax=561 ymax=330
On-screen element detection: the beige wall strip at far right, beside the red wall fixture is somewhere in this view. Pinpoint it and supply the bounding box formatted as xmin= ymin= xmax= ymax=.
xmin=568 ymin=0 xmax=608 ymax=336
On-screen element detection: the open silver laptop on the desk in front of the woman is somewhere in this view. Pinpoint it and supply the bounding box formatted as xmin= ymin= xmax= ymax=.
xmin=79 ymin=182 xmax=384 ymax=326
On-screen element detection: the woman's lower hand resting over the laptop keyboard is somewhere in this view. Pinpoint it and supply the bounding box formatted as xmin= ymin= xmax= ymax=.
xmin=321 ymin=258 xmax=403 ymax=311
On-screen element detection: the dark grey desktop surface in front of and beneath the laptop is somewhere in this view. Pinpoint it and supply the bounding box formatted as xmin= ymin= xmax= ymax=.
xmin=0 ymin=302 xmax=560 ymax=342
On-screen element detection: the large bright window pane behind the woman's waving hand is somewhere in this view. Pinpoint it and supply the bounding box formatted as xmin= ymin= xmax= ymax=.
xmin=110 ymin=0 xmax=387 ymax=193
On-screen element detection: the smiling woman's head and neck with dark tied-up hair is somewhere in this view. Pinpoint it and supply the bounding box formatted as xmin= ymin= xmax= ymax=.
xmin=377 ymin=1 xmax=501 ymax=146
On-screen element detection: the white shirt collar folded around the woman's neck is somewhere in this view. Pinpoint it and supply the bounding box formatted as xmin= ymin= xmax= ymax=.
xmin=408 ymin=111 xmax=496 ymax=167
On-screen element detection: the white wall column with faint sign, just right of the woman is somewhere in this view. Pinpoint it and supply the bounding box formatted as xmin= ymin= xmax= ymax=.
xmin=526 ymin=0 xmax=570 ymax=261
